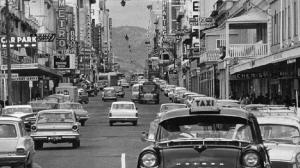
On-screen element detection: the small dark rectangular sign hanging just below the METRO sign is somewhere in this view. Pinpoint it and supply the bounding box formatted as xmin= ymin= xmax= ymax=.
xmin=53 ymin=54 xmax=75 ymax=69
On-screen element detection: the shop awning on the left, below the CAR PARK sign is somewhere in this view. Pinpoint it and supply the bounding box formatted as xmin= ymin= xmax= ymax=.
xmin=1 ymin=63 xmax=62 ymax=78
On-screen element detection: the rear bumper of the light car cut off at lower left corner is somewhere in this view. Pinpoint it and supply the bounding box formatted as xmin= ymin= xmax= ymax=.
xmin=0 ymin=154 xmax=27 ymax=166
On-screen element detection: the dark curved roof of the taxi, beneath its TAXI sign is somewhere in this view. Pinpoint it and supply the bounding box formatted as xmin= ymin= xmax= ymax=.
xmin=160 ymin=108 xmax=254 ymax=122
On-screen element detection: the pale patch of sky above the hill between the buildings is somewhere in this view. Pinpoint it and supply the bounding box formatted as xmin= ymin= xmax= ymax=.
xmin=106 ymin=0 xmax=150 ymax=28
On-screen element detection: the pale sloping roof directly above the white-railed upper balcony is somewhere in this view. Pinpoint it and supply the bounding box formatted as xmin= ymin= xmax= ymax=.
xmin=226 ymin=10 xmax=268 ymax=24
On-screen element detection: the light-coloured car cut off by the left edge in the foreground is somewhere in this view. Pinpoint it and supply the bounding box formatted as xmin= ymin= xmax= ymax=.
xmin=0 ymin=117 xmax=35 ymax=168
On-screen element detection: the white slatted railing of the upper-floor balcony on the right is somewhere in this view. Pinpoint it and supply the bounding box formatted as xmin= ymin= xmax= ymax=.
xmin=229 ymin=44 xmax=268 ymax=57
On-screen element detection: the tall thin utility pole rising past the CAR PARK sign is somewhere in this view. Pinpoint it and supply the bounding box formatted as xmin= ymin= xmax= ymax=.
xmin=5 ymin=0 xmax=12 ymax=104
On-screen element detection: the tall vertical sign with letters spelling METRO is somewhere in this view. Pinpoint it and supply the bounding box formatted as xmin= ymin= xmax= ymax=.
xmin=56 ymin=0 xmax=67 ymax=50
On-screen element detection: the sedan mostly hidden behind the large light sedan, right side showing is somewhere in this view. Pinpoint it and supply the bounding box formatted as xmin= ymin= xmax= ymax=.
xmin=58 ymin=102 xmax=90 ymax=126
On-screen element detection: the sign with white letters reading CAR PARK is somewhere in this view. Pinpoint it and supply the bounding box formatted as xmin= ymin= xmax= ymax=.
xmin=0 ymin=36 xmax=37 ymax=48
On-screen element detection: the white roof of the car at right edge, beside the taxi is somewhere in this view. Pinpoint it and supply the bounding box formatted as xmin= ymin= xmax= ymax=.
xmin=257 ymin=116 xmax=300 ymax=127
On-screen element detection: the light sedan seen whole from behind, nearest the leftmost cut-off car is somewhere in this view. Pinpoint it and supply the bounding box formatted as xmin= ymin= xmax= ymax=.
xmin=31 ymin=109 xmax=80 ymax=149
